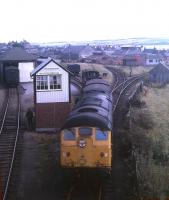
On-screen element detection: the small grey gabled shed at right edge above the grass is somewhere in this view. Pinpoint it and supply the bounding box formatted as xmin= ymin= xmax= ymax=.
xmin=149 ymin=63 xmax=169 ymax=85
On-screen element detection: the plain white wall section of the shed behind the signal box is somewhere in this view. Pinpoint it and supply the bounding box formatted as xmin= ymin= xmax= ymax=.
xmin=19 ymin=62 xmax=34 ymax=83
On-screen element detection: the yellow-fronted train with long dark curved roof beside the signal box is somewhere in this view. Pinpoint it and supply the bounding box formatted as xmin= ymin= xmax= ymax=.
xmin=60 ymin=79 xmax=113 ymax=168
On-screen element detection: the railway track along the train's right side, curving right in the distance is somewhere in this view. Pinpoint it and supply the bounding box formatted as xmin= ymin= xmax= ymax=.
xmin=112 ymin=76 xmax=142 ymax=200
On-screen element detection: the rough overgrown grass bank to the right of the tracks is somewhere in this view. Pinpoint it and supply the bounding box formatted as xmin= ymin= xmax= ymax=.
xmin=130 ymin=86 xmax=169 ymax=200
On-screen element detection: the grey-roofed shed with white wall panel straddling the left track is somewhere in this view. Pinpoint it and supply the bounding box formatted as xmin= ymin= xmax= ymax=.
xmin=0 ymin=47 xmax=37 ymax=83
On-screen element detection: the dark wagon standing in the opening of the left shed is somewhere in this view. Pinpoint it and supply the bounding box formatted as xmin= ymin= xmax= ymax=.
xmin=4 ymin=66 xmax=19 ymax=87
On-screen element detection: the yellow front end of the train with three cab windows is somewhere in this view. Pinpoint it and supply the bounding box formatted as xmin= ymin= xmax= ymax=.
xmin=60 ymin=127 xmax=112 ymax=168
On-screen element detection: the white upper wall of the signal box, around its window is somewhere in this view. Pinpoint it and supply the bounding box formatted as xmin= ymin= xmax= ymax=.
xmin=36 ymin=61 xmax=69 ymax=103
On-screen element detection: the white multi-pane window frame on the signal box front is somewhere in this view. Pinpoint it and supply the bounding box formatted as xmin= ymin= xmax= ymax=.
xmin=36 ymin=74 xmax=62 ymax=91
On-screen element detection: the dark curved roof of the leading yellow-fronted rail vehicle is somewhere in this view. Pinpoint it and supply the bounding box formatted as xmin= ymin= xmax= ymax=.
xmin=62 ymin=88 xmax=112 ymax=130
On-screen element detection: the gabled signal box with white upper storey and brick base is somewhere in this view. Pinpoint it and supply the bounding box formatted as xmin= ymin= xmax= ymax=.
xmin=31 ymin=58 xmax=80 ymax=131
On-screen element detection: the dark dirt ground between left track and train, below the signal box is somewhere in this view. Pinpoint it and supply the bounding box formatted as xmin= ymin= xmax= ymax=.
xmin=17 ymin=131 xmax=61 ymax=200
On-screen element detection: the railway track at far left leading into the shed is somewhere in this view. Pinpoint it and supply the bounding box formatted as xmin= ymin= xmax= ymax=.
xmin=0 ymin=88 xmax=20 ymax=200
